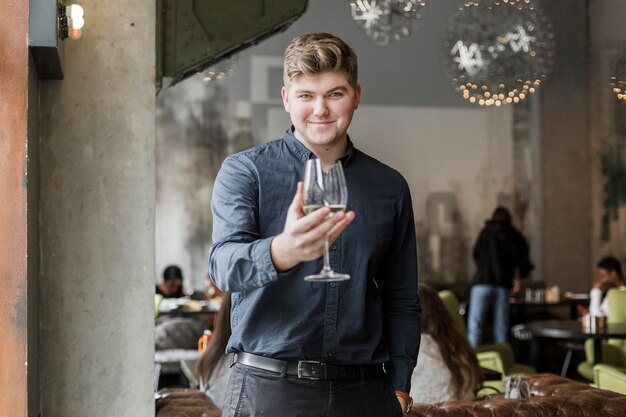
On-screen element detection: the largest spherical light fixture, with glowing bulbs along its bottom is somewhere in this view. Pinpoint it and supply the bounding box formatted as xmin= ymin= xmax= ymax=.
xmin=443 ymin=0 xmax=554 ymax=106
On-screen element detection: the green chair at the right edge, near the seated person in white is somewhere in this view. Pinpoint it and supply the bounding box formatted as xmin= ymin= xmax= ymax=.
xmin=577 ymin=288 xmax=626 ymax=381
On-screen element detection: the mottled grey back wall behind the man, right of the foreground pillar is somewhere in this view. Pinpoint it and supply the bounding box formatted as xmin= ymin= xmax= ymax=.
xmin=156 ymin=0 xmax=626 ymax=291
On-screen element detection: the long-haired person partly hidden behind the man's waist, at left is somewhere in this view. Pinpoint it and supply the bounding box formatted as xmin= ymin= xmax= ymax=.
xmin=196 ymin=293 xmax=232 ymax=407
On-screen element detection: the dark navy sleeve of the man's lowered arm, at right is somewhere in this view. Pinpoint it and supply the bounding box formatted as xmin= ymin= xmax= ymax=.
xmin=379 ymin=179 xmax=421 ymax=392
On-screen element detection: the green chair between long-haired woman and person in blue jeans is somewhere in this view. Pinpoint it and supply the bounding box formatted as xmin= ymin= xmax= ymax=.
xmin=439 ymin=290 xmax=537 ymax=392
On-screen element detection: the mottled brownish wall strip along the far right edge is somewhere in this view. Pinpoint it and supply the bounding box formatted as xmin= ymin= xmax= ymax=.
xmin=589 ymin=0 xmax=626 ymax=268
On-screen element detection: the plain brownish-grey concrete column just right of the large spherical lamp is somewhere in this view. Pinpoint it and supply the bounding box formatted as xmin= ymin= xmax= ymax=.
xmin=539 ymin=0 xmax=592 ymax=292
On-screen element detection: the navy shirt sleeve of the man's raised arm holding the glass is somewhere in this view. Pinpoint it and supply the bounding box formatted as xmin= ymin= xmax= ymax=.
xmin=209 ymin=155 xmax=278 ymax=292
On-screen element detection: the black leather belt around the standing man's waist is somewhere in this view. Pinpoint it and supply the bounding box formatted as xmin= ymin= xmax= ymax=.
xmin=233 ymin=352 xmax=385 ymax=381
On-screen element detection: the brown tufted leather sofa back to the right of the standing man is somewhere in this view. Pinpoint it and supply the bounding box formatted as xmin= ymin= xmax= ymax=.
xmin=409 ymin=374 xmax=626 ymax=417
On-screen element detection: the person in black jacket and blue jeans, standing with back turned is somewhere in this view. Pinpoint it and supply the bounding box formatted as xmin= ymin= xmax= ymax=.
xmin=467 ymin=207 xmax=534 ymax=347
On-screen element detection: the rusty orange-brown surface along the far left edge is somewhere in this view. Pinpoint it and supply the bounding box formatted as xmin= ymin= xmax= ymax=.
xmin=0 ymin=0 xmax=28 ymax=416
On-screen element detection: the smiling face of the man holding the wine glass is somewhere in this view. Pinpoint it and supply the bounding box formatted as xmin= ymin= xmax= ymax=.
xmin=281 ymin=72 xmax=361 ymax=152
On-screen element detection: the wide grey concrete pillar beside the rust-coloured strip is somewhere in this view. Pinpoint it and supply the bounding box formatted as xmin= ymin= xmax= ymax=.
xmin=39 ymin=0 xmax=155 ymax=417
